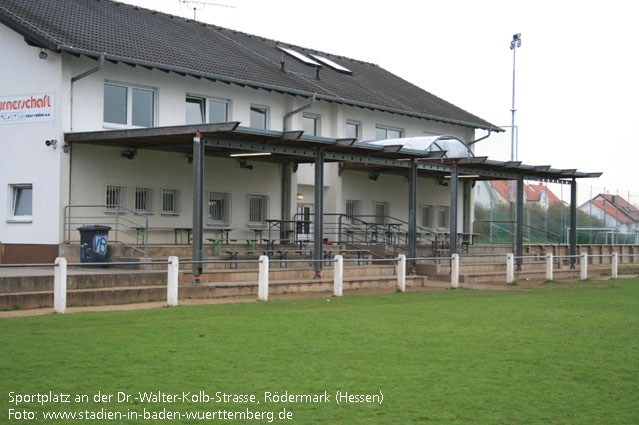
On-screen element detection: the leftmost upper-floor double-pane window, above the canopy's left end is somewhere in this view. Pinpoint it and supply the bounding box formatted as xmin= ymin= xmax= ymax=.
xmin=104 ymin=82 xmax=155 ymax=127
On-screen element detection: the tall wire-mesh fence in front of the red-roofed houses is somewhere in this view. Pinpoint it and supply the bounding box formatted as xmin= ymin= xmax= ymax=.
xmin=474 ymin=180 xmax=639 ymax=245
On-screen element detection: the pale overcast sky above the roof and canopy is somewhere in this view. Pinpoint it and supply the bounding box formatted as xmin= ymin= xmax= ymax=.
xmin=125 ymin=0 xmax=639 ymax=195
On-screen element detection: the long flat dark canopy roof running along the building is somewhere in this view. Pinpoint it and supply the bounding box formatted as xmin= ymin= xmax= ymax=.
xmin=65 ymin=122 xmax=602 ymax=183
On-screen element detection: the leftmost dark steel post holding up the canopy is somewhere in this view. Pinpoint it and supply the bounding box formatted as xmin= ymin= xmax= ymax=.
xmin=192 ymin=133 xmax=204 ymax=283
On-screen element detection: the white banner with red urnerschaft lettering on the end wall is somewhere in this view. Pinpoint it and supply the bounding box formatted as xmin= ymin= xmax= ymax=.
xmin=0 ymin=93 xmax=55 ymax=124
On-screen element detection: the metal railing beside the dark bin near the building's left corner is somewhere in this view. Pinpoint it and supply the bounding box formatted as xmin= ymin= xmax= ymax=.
xmin=63 ymin=204 xmax=149 ymax=257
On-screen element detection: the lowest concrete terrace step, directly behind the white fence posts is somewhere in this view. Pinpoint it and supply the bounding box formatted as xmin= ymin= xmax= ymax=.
xmin=0 ymin=276 xmax=427 ymax=309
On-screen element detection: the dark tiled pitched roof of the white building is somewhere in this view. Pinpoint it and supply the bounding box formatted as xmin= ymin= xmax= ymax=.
xmin=0 ymin=0 xmax=501 ymax=131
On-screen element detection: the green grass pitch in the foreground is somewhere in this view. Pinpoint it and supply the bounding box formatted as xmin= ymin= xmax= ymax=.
xmin=0 ymin=279 xmax=639 ymax=425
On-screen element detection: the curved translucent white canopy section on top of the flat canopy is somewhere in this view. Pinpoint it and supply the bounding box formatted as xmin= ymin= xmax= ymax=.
xmin=367 ymin=135 xmax=475 ymax=158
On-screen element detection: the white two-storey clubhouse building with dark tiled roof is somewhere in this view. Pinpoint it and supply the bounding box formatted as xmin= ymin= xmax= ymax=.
xmin=0 ymin=0 xmax=600 ymax=263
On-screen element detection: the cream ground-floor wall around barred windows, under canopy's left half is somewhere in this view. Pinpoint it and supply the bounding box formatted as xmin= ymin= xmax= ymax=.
xmin=71 ymin=145 xmax=281 ymax=243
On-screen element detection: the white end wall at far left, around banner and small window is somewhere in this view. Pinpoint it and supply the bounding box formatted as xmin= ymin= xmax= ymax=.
xmin=0 ymin=25 xmax=66 ymax=244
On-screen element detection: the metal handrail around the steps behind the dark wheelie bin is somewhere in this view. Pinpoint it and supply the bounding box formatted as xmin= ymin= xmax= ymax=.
xmin=63 ymin=204 xmax=149 ymax=257
